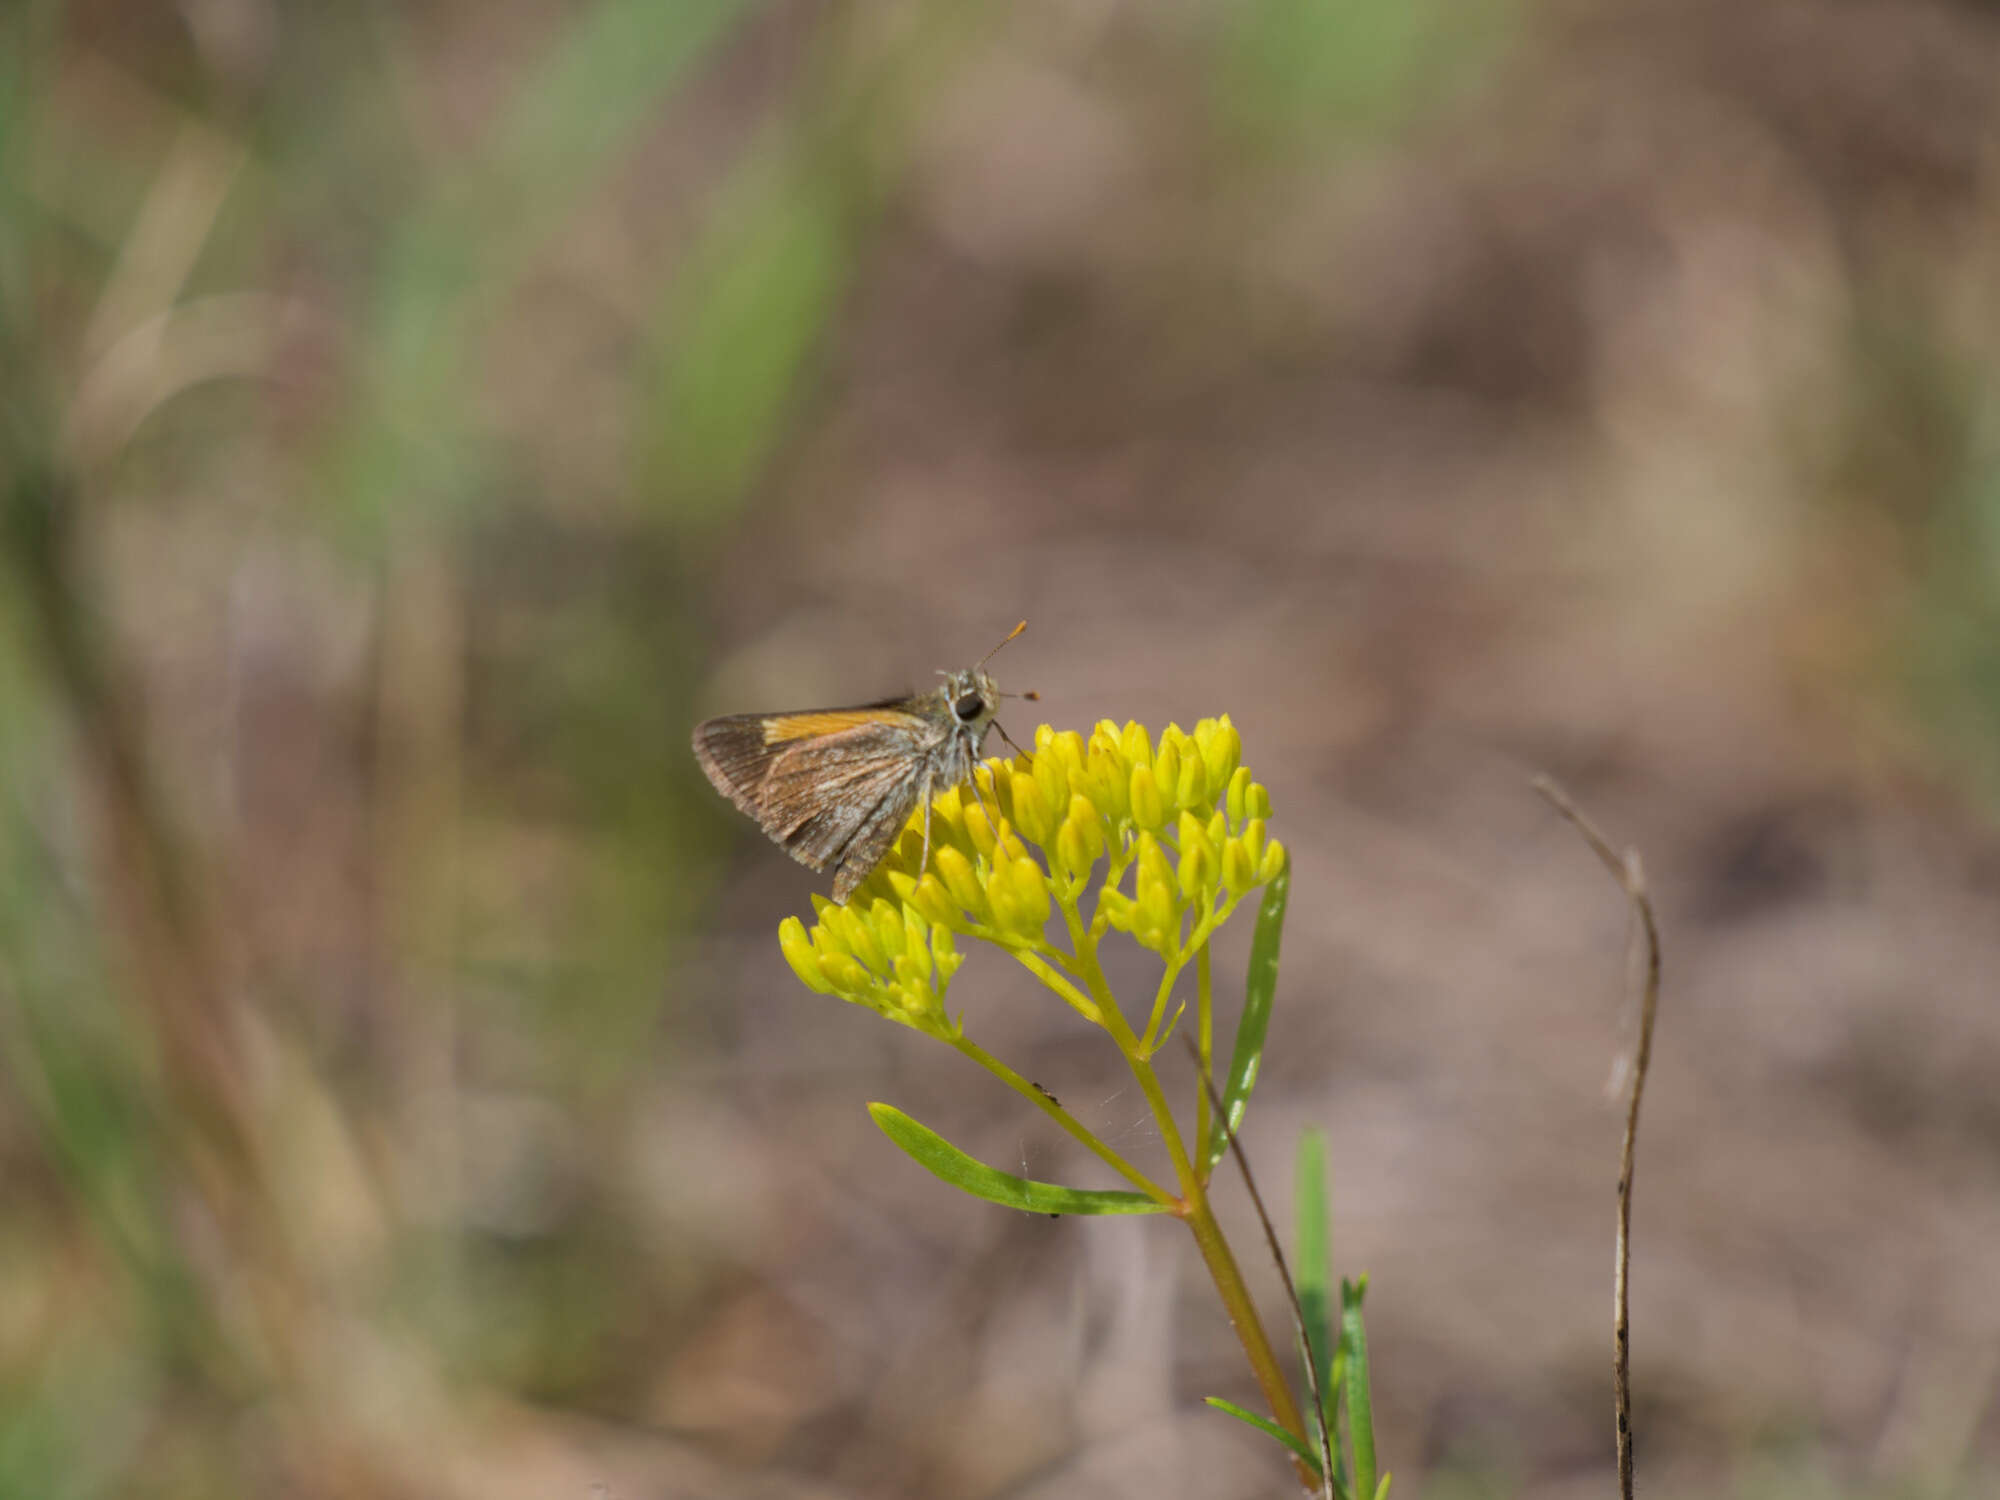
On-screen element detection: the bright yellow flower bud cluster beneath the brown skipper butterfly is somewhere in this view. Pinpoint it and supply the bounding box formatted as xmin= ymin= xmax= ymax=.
xmin=778 ymin=714 xmax=1286 ymax=1038
